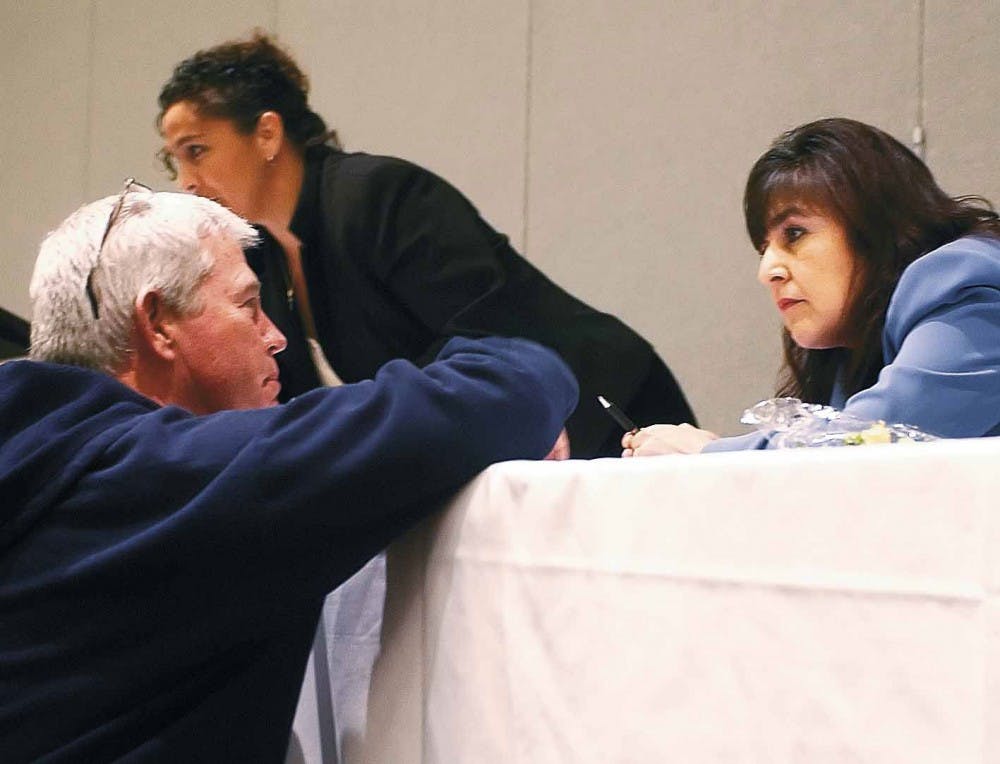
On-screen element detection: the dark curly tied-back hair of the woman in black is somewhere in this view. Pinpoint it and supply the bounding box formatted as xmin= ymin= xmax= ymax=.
xmin=156 ymin=29 xmax=340 ymax=175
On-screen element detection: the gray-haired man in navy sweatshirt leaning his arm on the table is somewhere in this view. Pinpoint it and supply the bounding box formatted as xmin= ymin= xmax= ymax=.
xmin=0 ymin=182 xmax=576 ymax=762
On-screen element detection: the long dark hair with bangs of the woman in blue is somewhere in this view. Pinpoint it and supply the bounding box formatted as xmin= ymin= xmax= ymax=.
xmin=743 ymin=118 xmax=1000 ymax=403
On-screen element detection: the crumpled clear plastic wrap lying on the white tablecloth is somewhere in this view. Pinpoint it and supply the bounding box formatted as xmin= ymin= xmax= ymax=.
xmin=740 ymin=398 xmax=937 ymax=448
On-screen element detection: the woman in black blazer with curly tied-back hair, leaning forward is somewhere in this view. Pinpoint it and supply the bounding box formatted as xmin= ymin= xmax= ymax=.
xmin=158 ymin=33 xmax=693 ymax=458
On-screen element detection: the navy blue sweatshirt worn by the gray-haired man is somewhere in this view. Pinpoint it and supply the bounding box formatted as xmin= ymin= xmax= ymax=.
xmin=0 ymin=339 xmax=577 ymax=763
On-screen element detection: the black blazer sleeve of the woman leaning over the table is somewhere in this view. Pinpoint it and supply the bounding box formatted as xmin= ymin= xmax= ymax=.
xmin=348 ymin=160 xmax=694 ymax=457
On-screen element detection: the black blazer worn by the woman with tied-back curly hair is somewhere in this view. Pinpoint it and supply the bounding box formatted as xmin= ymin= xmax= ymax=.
xmin=247 ymin=146 xmax=694 ymax=458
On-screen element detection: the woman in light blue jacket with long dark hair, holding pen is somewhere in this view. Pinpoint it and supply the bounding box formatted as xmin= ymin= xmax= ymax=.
xmin=622 ymin=119 xmax=1000 ymax=456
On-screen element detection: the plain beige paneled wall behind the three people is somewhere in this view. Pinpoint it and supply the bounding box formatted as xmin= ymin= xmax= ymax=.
xmin=0 ymin=0 xmax=1000 ymax=432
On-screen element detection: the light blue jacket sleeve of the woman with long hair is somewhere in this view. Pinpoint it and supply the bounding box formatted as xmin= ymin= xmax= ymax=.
xmin=845 ymin=237 xmax=1000 ymax=438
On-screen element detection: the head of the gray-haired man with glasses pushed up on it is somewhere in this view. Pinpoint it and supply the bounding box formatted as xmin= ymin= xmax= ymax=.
xmin=30 ymin=180 xmax=285 ymax=414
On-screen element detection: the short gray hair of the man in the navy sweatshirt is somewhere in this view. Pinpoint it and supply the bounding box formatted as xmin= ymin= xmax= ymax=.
xmin=29 ymin=188 xmax=258 ymax=374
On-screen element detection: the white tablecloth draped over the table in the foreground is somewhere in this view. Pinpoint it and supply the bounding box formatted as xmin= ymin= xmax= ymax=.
xmin=350 ymin=439 xmax=1000 ymax=764
